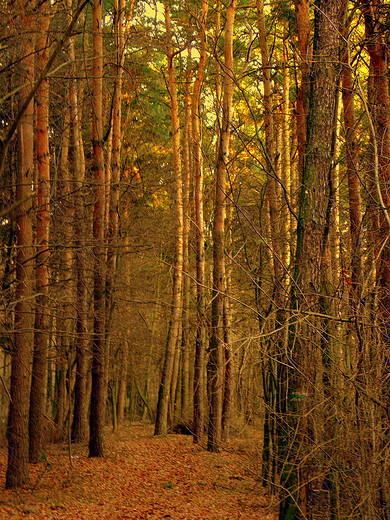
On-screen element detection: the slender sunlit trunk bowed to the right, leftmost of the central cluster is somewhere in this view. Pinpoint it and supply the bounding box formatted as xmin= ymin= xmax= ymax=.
xmin=154 ymin=2 xmax=183 ymax=435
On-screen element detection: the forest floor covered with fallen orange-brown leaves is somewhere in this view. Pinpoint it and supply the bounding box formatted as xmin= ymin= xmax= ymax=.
xmin=0 ymin=424 xmax=278 ymax=520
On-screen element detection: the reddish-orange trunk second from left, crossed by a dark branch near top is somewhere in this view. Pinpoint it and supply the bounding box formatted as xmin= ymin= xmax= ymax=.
xmin=29 ymin=2 xmax=50 ymax=463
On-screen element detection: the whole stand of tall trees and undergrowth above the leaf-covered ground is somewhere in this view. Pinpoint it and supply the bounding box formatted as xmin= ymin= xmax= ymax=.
xmin=0 ymin=0 xmax=390 ymax=520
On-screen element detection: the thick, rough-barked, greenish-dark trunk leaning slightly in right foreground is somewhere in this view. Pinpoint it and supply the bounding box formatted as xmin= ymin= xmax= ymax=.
xmin=280 ymin=0 xmax=345 ymax=519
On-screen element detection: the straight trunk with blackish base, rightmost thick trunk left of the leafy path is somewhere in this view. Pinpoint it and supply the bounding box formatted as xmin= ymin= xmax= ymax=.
xmin=89 ymin=0 xmax=107 ymax=457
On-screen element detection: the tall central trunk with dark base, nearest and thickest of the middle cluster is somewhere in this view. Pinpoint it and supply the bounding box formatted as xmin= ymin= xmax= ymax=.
xmin=207 ymin=0 xmax=236 ymax=452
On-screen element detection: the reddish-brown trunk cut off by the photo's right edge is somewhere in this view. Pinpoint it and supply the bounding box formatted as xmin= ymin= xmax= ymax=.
xmin=358 ymin=0 xmax=390 ymax=520
